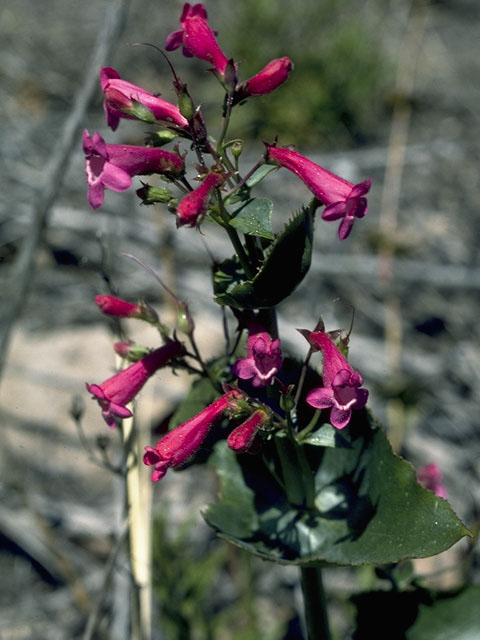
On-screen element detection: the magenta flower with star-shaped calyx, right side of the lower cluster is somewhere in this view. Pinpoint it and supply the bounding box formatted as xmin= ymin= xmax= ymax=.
xmin=307 ymin=331 xmax=368 ymax=429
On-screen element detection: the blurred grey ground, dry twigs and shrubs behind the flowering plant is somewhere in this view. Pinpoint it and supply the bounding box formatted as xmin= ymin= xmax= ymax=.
xmin=0 ymin=0 xmax=480 ymax=640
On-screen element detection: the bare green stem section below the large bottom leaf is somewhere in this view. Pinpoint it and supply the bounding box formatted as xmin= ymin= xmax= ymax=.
xmin=300 ymin=567 xmax=331 ymax=640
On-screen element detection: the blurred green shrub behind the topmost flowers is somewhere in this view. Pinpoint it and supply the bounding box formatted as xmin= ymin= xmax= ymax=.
xmin=225 ymin=0 xmax=391 ymax=148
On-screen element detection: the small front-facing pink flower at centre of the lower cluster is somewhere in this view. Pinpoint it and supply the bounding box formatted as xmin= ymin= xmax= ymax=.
xmin=232 ymin=331 xmax=283 ymax=387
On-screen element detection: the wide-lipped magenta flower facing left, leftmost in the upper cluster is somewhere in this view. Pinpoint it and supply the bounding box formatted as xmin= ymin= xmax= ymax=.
xmin=83 ymin=129 xmax=184 ymax=209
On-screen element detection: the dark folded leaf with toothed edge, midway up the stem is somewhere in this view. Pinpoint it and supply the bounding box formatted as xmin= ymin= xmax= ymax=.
xmin=213 ymin=208 xmax=313 ymax=309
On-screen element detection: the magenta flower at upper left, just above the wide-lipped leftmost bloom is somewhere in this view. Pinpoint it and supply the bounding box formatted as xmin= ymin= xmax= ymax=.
xmin=100 ymin=67 xmax=188 ymax=131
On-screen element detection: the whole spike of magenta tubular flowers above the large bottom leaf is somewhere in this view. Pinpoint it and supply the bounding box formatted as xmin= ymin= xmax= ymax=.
xmin=83 ymin=3 xmax=370 ymax=481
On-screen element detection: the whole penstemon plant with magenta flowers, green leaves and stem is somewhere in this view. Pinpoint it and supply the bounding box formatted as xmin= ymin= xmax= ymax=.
xmin=83 ymin=4 xmax=470 ymax=639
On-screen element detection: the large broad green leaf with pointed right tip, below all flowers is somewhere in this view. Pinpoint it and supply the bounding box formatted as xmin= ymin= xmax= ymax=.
xmin=205 ymin=411 xmax=470 ymax=565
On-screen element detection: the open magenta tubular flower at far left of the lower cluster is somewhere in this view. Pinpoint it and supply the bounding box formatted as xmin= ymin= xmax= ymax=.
xmin=86 ymin=340 xmax=183 ymax=428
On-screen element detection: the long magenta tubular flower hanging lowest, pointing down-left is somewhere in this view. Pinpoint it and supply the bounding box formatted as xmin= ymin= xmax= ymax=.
xmin=143 ymin=389 xmax=242 ymax=482
